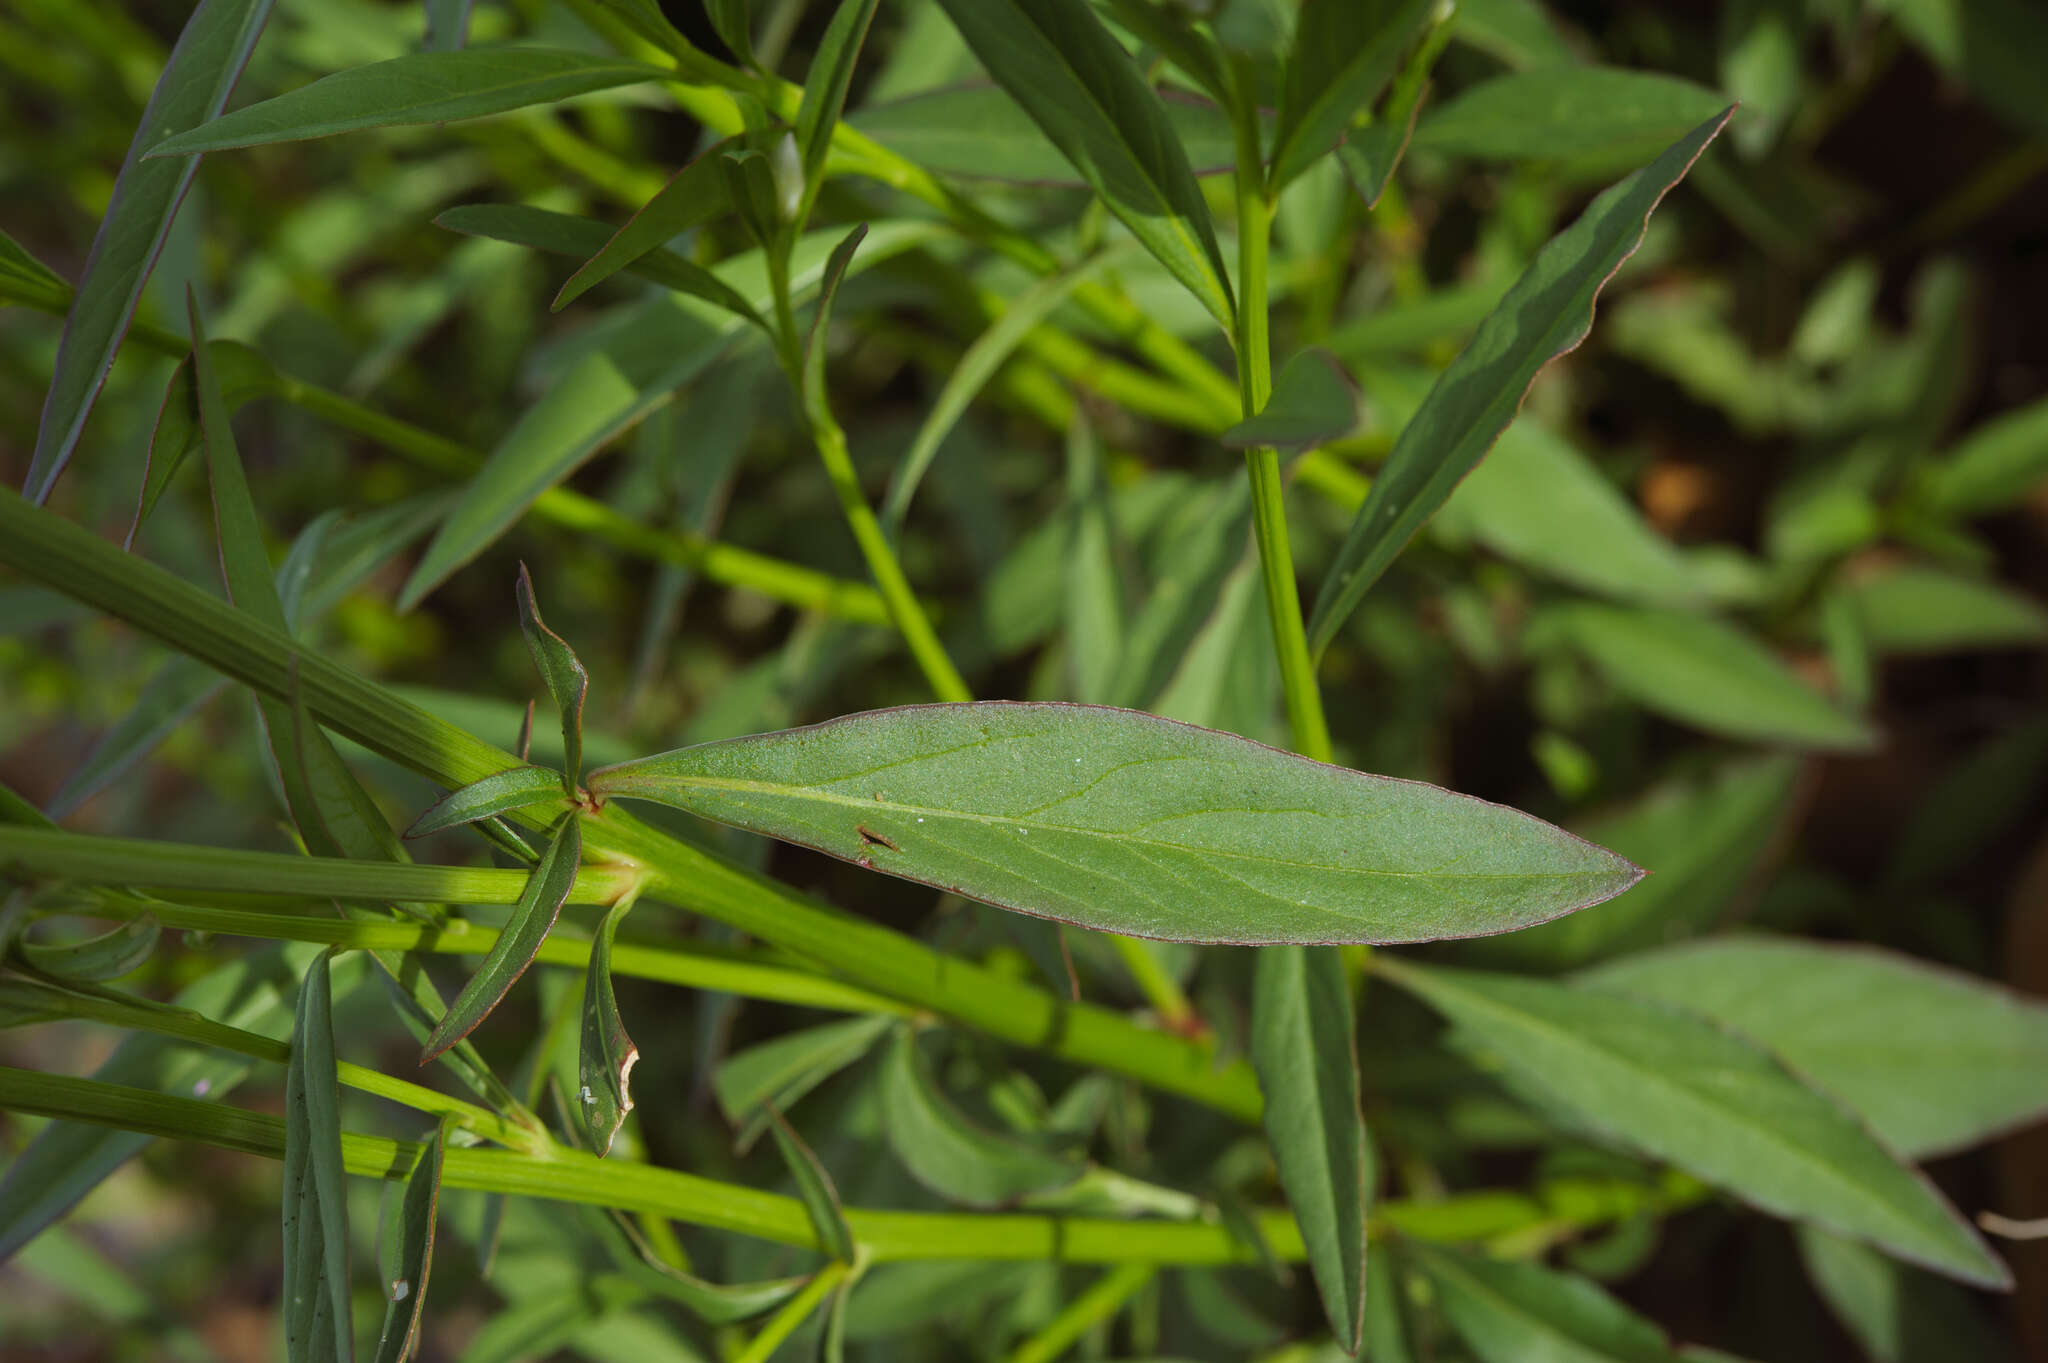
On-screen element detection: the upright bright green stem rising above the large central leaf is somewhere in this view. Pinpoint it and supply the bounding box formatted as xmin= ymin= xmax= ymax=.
xmin=1233 ymin=63 xmax=1335 ymax=761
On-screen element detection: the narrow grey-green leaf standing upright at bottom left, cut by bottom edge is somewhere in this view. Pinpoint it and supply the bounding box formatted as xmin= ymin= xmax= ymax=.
xmin=285 ymin=952 xmax=354 ymax=1363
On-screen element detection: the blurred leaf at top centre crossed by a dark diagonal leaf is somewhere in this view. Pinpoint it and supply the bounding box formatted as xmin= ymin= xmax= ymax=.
xmin=846 ymin=84 xmax=1237 ymax=188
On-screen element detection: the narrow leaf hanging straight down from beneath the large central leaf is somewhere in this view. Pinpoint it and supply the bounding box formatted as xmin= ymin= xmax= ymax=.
xmin=1251 ymin=946 xmax=1378 ymax=1353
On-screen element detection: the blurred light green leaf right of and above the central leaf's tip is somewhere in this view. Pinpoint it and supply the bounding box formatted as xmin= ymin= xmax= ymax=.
xmin=1530 ymin=602 xmax=1876 ymax=749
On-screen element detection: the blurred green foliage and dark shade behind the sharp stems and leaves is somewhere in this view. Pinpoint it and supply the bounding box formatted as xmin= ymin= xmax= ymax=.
xmin=0 ymin=0 xmax=2048 ymax=1361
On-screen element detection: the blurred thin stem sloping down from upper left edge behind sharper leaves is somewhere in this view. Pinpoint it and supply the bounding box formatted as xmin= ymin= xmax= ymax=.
xmin=8 ymin=293 xmax=889 ymax=624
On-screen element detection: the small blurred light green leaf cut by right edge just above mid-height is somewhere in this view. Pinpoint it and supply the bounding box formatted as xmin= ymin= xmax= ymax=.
xmin=1835 ymin=563 xmax=2048 ymax=653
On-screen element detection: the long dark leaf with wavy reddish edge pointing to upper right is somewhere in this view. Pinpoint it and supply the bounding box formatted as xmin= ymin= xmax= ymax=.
xmin=1309 ymin=113 xmax=1729 ymax=651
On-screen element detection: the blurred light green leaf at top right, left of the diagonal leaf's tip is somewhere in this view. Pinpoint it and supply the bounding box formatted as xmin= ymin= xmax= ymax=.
xmin=1415 ymin=65 xmax=1729 ymax=160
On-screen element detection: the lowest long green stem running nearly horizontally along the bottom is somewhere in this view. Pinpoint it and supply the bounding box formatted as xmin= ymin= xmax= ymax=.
xmin=0 ymin=1066 xmax=1710 ymax=1265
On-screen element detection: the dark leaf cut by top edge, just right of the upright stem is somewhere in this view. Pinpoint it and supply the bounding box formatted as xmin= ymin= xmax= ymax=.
xmin=1266 ymin=0 xmax=1436 ymax=192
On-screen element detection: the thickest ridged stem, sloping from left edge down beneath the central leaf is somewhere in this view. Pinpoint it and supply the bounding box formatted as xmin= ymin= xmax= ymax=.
xmin=0 ymin=487 xmax=1262 ymax=1122
